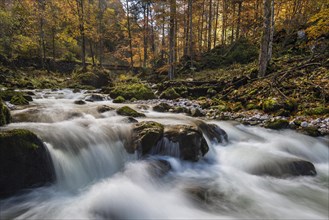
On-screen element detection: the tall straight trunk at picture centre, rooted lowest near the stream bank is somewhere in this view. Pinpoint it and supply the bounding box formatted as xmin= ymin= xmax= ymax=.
xmin=168 ymin=0 xmax=176 ymax=80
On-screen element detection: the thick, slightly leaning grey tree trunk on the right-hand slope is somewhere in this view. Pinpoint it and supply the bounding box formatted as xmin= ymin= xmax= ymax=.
xmin=258 ymin=0 xmax=272 ymax=77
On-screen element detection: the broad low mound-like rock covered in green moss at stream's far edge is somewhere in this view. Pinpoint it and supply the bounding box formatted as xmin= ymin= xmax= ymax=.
xmin=110 ymin=83 xmax=156 ymax=100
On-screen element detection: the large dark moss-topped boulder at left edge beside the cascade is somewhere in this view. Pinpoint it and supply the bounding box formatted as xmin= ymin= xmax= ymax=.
xmin=0 ymin=129 xmax=55 ymax=197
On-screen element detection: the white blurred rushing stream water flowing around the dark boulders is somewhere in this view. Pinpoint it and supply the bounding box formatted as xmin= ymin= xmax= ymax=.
xmin=0 ymin=90 xmax=329 ymax=219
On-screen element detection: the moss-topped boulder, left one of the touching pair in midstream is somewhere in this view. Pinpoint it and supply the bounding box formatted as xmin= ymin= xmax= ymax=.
xmin=126 ymin=121 xmax=164 ymax=157
